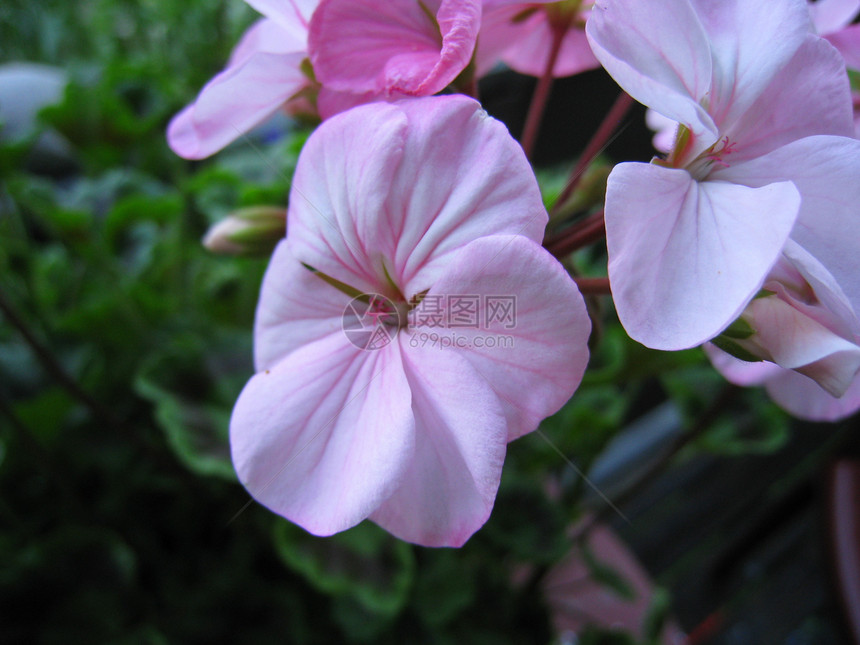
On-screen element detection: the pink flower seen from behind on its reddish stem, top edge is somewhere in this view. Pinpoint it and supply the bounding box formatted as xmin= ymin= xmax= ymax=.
xmin=476 ymin=0 xmax=600 ymax=78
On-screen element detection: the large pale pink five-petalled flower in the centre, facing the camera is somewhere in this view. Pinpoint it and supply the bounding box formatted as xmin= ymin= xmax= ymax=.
xmin=230 ymin=96 xmax=590 ymax=546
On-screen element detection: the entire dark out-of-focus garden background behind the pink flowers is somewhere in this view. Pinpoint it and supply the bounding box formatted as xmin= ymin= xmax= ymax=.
xmin=0 ymin=0 xmax=856 ymax=644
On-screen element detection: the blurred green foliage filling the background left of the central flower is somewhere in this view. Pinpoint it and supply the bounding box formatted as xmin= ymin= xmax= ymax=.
xmin=0 ymin=0 xmax=800 ymax=644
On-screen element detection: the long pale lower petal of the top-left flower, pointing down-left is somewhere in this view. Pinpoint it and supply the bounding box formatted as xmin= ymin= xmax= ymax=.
xmin=167 ymin=53 xmax=307 ymax=159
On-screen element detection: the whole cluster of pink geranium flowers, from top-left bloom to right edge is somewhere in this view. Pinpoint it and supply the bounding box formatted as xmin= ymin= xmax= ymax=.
xmin=168 ymin=0 xmax=860 ymax=546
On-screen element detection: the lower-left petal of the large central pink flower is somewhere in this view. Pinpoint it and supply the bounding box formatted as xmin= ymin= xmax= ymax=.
xmin=230 ymin=334 xmax=415 ymax=535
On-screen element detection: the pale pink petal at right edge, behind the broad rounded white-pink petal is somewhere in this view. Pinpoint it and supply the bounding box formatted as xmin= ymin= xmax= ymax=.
xmin=719 ymin=136 xmax=860 ymax=311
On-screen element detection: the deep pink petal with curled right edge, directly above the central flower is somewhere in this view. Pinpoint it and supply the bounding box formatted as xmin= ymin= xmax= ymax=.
xmin=309 ymin=0 xmax=481 ymax=96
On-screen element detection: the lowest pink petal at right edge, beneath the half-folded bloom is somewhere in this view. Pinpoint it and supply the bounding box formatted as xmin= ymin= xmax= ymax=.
xmin=765 ymin=370 xmax=860 ymax=421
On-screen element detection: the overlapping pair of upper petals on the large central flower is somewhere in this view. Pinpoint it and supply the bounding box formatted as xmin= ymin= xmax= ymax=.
xmin=288 ymin=96 xmax=547 ymax=297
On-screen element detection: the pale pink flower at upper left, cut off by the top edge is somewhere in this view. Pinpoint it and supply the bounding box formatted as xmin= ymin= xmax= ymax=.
xmin=167 ymin=0 xmax=318 ymax=159
